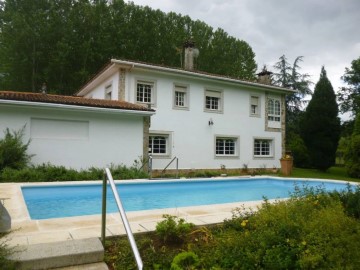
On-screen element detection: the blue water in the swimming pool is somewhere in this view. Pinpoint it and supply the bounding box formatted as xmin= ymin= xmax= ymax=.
xmin=22 ymin=178 xmax=352 ymax=219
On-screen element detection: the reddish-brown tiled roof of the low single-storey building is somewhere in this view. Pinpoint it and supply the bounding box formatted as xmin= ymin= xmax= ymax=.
xmin=0 ymin=91 xmax=154 ymax=112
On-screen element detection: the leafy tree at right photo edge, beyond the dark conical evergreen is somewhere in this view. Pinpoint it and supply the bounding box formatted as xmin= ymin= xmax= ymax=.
xmin=338 ymin=57 xmax=360 ymax=115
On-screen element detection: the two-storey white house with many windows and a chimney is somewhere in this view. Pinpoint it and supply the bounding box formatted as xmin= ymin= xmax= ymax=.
xmin=77 ymin=47 xmax=292 ymax=172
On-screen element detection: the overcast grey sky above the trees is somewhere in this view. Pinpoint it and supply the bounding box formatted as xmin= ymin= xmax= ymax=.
xmin=128 ymin=0 xmax=360 ymax=117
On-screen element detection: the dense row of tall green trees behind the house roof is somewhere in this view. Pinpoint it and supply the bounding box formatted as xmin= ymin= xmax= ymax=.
xmin=0 ymin=0 xmax=256 ymax=94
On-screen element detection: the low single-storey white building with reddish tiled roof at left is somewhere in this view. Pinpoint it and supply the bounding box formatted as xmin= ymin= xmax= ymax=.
xmin=0 ymin=91 xmax=154 ymax=169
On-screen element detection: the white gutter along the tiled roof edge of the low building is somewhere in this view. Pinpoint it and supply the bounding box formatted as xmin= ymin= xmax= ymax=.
xmin=0 ymin=99 xmax=155 ymax=116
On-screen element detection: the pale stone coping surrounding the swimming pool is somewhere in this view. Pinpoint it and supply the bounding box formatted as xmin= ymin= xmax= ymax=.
xmin=0 ymin=176 xmax=358 ymax=246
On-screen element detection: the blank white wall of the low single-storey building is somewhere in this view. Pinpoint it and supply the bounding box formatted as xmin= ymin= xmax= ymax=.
xmin=0 ymin=104 xmax=143 ymax=169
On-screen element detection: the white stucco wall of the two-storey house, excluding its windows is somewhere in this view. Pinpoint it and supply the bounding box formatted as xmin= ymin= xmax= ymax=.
xmin=86 ymin=68 xmax=282 ymax=169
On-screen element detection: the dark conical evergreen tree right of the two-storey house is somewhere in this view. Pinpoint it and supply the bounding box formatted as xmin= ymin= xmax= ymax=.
xmin=301 ymin=67 xmax=340 ymax=171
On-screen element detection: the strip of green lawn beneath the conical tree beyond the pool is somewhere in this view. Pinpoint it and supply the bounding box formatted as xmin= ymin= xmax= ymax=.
xmin=291 ymin=166 xmax=360 ymax=182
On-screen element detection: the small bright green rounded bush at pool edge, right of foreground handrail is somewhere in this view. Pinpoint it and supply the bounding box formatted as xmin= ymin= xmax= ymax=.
xmin=156 ymin=215 xmax=194 ymax=243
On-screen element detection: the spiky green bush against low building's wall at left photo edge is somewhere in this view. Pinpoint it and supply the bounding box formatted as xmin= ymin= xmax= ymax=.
xmin=0 ymin=126 xmax=31 ymax=171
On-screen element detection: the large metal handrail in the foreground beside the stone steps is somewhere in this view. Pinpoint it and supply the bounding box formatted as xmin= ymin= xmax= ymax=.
xmin=101 ymin=168 xmax=143 ymax=270
